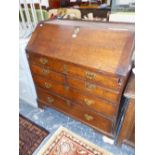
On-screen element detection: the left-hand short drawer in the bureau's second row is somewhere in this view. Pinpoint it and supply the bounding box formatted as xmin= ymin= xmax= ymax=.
xmin=30 ymin=63 xmax=65 ymax=83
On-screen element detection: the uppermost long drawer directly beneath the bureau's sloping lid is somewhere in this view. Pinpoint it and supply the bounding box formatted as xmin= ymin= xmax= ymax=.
xmin=29 ymin=53 xmax=124 ymax=90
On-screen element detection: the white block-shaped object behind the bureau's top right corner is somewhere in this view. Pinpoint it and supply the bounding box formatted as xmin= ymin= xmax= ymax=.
xmin=109 ymin=12 xmax=135 ymax=23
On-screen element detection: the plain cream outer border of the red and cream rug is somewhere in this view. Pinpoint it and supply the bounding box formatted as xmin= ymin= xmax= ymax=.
xmin=37 ymin=126 xmax=114 ymax=155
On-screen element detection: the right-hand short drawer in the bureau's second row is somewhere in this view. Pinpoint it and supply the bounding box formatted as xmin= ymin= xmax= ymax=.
xmin=67 ymin=77 xmax=120 ymax=103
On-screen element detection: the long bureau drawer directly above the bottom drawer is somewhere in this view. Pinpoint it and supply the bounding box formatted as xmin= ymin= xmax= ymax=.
xmin=33 ymin=76 xmax=117 ymax=119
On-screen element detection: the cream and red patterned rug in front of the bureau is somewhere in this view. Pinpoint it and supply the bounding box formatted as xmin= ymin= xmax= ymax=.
xmin=37 ymin=127 xmax=112 ymax=155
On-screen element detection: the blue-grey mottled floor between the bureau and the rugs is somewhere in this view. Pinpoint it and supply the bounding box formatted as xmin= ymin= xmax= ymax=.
xmin=19 ymin=101 xmax=135 ymax=155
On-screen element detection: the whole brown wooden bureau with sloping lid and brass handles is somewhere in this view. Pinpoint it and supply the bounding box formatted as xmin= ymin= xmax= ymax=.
xmin=26 ymin=20 xmax=134 ymax=138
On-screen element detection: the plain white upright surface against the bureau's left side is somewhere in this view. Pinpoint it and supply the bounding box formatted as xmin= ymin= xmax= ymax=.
xmin=19 ymin=38 xmax=37 ymax=107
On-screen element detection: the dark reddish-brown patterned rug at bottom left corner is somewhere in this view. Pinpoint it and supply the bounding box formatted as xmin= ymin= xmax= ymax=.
xmin=19 ymin=114 xmax=48 ymax=155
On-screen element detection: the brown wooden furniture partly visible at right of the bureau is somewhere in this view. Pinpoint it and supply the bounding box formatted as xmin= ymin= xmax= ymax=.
xmin=117 ymin=73 xmax=135 ymax=147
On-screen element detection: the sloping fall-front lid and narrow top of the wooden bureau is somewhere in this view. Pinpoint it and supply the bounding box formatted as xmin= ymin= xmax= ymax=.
xmin=26 ymin=20 xmax=134 ymax=76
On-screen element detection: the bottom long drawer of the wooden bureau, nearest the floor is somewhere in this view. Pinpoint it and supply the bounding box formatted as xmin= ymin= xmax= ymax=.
xmin=37 ymin=89 xmax=113 ymax=133
